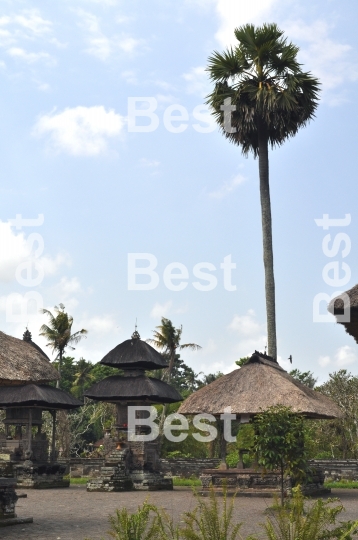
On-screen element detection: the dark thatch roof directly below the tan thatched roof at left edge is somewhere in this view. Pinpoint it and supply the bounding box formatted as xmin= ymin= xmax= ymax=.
xmin=0 ymin=384 xmax=83 ymax=409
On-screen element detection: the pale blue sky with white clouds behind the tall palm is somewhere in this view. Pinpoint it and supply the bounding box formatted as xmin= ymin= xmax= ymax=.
xmin=0 ymin=0 xmax=358 ymax=381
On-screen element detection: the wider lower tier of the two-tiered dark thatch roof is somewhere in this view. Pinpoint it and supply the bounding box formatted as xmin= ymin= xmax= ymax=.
xmin=84 ymin=373 xmax=183 ymax=403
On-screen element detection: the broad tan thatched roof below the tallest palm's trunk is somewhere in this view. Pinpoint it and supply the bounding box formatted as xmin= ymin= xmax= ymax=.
xmin=178 ymin=351 xmax=342 ymax=418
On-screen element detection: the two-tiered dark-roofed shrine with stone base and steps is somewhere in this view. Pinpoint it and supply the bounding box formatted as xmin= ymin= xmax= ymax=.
xmin=85 ymin=331 xmax=182 ymax=491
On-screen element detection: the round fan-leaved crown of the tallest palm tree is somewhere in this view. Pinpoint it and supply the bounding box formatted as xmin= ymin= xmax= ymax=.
xmin=207 ymin=24 xmax=320 ymax=156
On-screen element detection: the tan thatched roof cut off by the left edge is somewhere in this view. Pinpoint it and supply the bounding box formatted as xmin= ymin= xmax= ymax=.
xmin=0 ymin=332 xmax=59 ymax=386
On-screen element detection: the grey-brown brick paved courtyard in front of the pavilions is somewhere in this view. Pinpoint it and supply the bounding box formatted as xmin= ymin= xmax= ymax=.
xmin=0 ymin=486 xmax=358 ymax=540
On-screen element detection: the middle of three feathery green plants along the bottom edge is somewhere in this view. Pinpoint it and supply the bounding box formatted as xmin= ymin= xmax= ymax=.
xmin=180 ymin=489 xmax=241 ymax=540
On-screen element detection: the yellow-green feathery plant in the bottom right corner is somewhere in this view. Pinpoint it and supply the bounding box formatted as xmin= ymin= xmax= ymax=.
xmin=263 ymin=487 xmax=358 ymax=540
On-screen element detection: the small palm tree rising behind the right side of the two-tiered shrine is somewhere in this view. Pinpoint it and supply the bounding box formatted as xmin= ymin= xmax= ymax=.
xmin=147 ymin=317 xmax=201 ymax=382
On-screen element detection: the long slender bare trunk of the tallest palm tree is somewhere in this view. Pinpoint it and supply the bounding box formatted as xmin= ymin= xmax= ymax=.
xmin=258 ymin=120 xmax=277 ymax=360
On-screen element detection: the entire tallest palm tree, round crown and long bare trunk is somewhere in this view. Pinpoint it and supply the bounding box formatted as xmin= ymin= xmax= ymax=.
xmin=207 ymin=24 xmax=320 ymax=359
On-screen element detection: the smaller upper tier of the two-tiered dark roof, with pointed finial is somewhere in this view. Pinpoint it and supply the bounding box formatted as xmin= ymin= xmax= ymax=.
xmin=101 ymin=331 xmax=168 ymax=371
